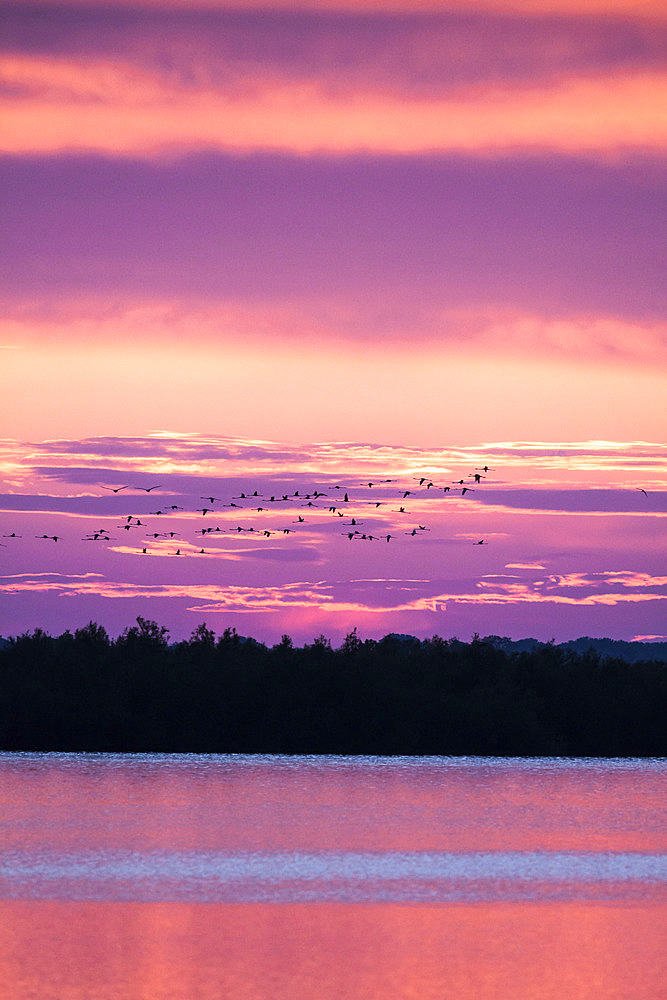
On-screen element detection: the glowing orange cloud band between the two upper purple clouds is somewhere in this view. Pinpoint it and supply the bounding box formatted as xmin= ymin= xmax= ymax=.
xmin=0 ymin=56 xmax=667 ymax=156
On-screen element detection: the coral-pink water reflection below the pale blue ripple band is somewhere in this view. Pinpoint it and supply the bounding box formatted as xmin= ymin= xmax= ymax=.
xmin=0 ymin=902 xmax=667 ymax=1000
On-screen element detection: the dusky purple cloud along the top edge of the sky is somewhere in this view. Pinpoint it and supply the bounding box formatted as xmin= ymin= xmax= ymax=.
xmin=3 ymin=4 xmax=665 ymax=97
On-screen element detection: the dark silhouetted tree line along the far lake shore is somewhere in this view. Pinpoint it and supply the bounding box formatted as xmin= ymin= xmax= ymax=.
xmin=0 ymin=618 xmax=667 ymax=757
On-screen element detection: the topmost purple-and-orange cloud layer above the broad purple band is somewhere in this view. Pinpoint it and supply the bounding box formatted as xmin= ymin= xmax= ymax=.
xmin=0 ymin=4 xmax=666 ymax=156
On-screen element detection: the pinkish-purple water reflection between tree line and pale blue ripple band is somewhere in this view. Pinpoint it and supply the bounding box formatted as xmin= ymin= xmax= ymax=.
xmin=0 ymin=754 xmax=667 ymax=852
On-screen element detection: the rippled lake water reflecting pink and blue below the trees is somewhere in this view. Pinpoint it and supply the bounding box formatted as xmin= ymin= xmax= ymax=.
xmin=0 ymin=754 xmax=667 ymax=1000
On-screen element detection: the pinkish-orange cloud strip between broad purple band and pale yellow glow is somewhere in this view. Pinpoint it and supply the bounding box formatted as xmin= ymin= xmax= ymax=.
xmin=0 ymin=297 xmax=667 ymax=365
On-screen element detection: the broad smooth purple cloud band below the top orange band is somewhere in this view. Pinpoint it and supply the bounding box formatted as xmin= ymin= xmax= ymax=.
xmin=0 ymin=154 xmax=663 ymax=324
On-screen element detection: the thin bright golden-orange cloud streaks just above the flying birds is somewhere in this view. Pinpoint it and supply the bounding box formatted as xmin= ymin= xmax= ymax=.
xmin=6 ymin=431 xmax=667 ymax=494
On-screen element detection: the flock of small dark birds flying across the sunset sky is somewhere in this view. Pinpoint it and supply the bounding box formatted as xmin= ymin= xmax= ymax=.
xmin=0 ymin=465 xmax=493 ymax=556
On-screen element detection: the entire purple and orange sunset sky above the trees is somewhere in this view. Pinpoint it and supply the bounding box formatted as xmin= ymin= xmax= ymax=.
xmin=0 ymin=0 xmax=667 ymax=644
